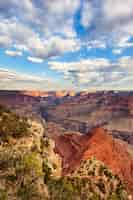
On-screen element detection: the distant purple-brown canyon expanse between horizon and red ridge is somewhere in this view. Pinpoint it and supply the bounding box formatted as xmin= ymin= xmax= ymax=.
xmin=0 ymin=91 xmax=133 ymax=144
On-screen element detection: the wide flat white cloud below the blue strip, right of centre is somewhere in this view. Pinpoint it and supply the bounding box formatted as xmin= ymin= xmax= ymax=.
xmin=48 ymin=58 xmax=113 ymax=86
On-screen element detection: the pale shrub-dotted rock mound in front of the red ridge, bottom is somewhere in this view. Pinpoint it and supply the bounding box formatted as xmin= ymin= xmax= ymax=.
xmin=47 ymin=158 xmax=131 ymax=200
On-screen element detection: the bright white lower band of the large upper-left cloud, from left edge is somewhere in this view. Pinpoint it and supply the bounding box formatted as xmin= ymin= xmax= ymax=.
xmin=0 ymin=20 xmax=80 ymax=59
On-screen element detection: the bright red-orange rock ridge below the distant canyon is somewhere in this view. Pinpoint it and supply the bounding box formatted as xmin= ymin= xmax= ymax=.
xmin=55 ymin=128 xmax=133 ymax=194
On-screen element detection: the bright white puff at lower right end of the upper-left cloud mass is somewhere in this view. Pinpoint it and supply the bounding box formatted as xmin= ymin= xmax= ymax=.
xmin=28 ymin=36 xmax=80 ymax=58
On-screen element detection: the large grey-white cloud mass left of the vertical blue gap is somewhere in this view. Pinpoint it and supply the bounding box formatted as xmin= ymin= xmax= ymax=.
xmin=0 ymin=0 xmax=80 ymax=58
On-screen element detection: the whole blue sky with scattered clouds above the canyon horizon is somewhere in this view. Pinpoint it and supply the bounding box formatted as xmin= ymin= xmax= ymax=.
xmin=0 ymin=0 xmax=133 ymax=91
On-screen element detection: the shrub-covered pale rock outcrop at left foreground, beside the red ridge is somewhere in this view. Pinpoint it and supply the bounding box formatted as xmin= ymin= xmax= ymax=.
xmin=0 ymin=107 xmax=61 ymax=200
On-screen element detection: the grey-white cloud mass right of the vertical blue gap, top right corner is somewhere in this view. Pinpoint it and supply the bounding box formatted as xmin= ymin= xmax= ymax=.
xmin=81 ymin=0 xmax=133 ymax=48
